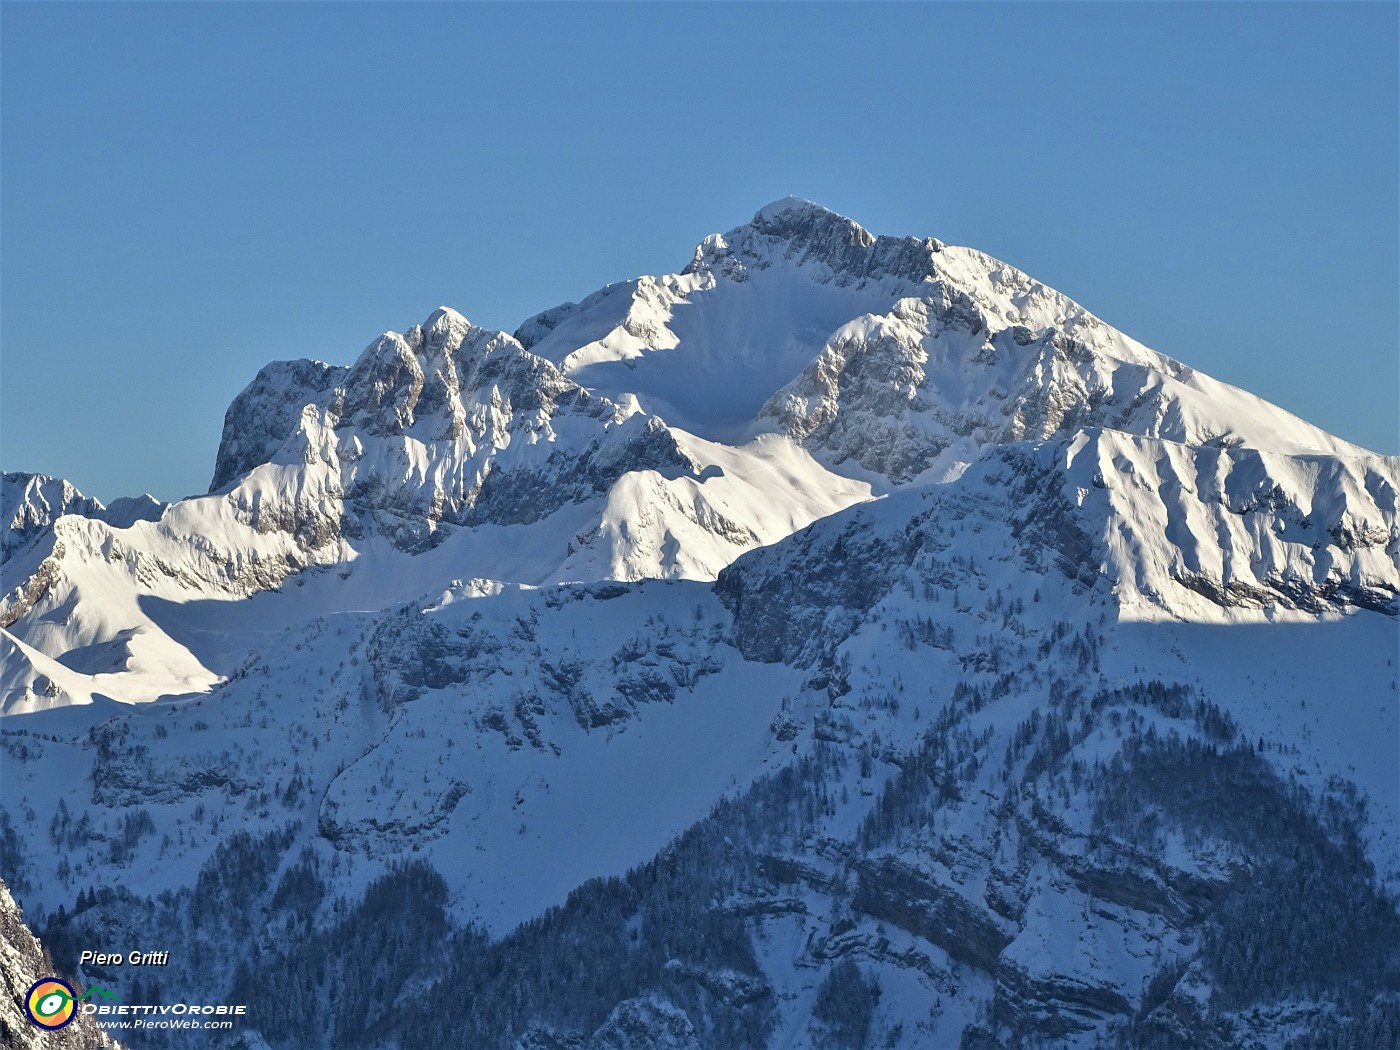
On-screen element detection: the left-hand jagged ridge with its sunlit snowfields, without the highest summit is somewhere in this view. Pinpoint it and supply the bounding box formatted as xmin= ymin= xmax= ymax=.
xmin=0 ymin=309 xmax=869 ymax=710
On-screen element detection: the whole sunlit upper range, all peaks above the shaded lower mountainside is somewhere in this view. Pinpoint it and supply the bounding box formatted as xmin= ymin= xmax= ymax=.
xmin=8 ymin=199 xmax=1397 ymax=704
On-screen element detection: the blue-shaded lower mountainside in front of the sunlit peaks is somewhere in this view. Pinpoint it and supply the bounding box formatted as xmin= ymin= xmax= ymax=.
xmin=0 ymin=433 xmax=1400 ymax=1047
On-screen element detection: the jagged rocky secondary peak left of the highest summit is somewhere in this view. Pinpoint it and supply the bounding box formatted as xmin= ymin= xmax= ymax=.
xmin=214 ymin=308 xmax=694 ymax=550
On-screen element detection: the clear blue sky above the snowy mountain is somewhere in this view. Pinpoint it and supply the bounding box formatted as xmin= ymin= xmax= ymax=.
xmin=0 ymin=3 xmax=1400 ymax=500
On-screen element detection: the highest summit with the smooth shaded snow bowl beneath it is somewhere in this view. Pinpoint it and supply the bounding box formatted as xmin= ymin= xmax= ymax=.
xmin=515 ymin=197 xmax=942 ymax=444
